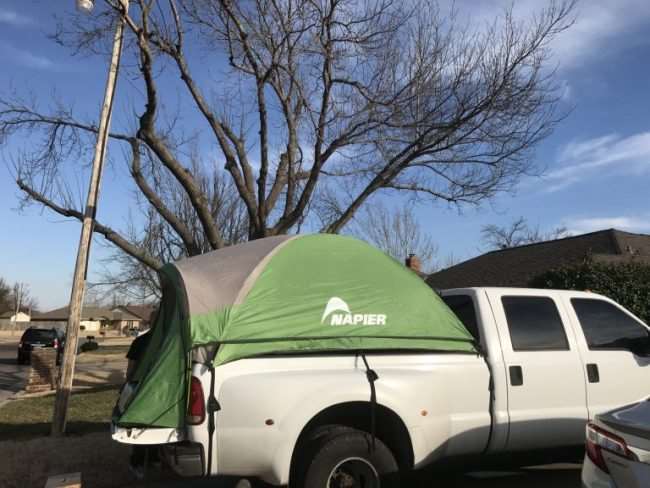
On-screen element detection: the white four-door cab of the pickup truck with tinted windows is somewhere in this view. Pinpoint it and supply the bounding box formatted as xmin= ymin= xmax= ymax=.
xmin=441 ymin=288 xmax=650 ymax=452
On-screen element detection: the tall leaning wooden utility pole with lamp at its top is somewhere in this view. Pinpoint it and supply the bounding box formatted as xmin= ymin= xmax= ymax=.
xmin=51 ymin=0 xmax=129 ymax=436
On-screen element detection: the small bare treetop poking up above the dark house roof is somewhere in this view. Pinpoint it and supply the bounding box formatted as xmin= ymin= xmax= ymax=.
xmin=481 ymin=217 xmax=571 ymax=249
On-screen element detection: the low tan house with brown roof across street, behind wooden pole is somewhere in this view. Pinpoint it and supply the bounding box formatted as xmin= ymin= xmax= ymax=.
xmin=32 ymin=305 xmax=143 ymax=333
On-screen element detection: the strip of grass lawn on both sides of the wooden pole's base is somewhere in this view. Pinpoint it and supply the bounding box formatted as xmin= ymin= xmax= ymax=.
xmin=0 ymin=386 xmax=118 ymax=440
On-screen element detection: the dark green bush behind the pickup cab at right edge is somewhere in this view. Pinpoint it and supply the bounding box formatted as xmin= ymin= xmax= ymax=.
xmin=530 ymin=258 xmax=650 ymax=324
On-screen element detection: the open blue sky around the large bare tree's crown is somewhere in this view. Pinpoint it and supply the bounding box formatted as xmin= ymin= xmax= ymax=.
xmin=0 ymin=0 xmax=650 ymax=309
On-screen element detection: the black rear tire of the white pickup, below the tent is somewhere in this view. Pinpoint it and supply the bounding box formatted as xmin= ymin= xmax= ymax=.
xmin=294 ymin=429 xmax=400 ymax=488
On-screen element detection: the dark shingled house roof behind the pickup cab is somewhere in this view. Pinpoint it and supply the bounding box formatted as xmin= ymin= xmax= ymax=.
xmin=426 ymin=229 xmax=650 ymax=289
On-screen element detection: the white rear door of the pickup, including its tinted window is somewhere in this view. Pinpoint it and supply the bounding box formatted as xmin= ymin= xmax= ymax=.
xmin=489 ymin=290 xmax=587 ymax=450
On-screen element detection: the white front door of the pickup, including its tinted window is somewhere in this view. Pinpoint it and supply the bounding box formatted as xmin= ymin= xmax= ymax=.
xmin=565 ymin=294 xmax=650 ymax=418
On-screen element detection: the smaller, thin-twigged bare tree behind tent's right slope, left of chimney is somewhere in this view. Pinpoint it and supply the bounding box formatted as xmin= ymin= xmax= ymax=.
xmin=351 ymin=203 xmax=438 ymax=273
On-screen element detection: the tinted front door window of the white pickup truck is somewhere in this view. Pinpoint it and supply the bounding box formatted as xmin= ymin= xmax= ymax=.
xmin=571 ymin=298 xmax=648 ymax=349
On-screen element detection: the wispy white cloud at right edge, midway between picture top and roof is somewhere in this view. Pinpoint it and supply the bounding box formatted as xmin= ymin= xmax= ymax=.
xmin=544 ymin=131 xmax=650 ymax=192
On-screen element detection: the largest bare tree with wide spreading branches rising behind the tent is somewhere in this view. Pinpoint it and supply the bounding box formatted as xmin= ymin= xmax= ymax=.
xmin=0 ymin=0 xmax=574 ymax=269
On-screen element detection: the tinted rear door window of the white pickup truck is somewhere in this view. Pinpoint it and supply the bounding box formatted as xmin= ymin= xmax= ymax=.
xmin=501 ymin=296 xmax=569 ymax=351
